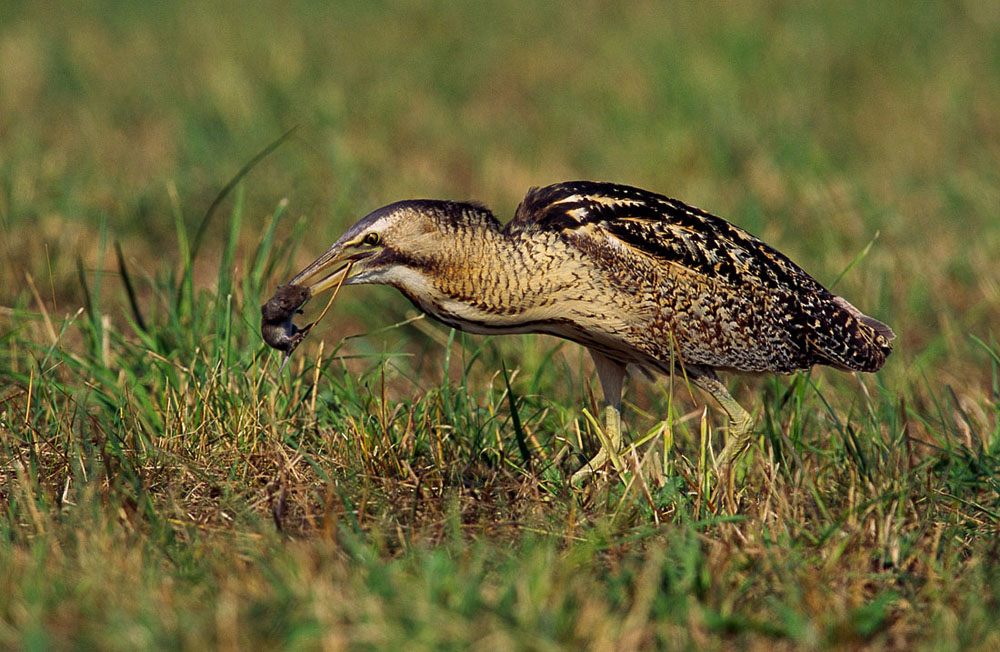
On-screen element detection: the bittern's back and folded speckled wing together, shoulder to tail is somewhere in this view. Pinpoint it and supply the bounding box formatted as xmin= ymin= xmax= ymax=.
xmin=505 ymin=181 xmax=894 ymax=372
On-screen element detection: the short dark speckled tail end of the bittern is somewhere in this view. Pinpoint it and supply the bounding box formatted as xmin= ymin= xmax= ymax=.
xmin=809 ymin=297 xmax=896 ymax=372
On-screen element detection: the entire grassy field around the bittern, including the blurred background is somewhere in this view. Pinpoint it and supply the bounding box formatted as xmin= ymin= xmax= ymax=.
xmin=0 ymin=1 xmax=1000 ymax=650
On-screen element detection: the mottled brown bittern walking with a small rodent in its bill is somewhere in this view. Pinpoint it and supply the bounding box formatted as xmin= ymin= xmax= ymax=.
xmin=265 ymin=181 xmax=894 ymax=487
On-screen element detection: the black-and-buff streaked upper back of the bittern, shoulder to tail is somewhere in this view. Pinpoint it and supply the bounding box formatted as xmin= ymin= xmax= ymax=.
xmin=506 ymin=181 xmax=895 ymax=371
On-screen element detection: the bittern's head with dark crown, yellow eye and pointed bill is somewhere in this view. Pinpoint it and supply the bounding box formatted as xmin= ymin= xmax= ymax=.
xmin=291 ymin=199 xmax=495 ymax=296
